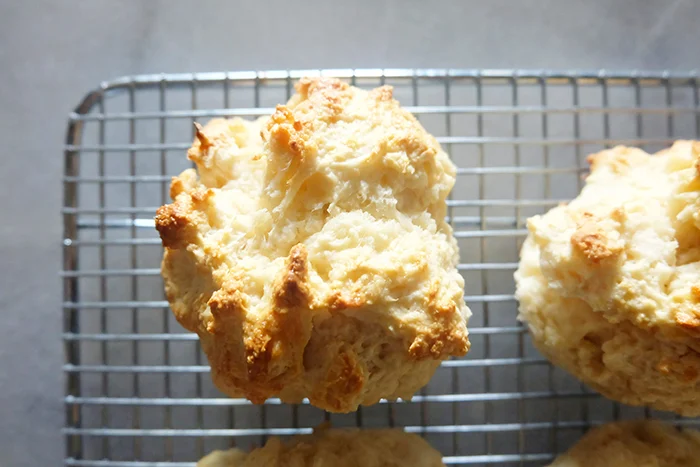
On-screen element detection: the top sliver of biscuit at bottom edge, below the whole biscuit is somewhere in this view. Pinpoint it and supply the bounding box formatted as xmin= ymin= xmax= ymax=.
xmin=197 ymin=427 xmax=444 ymax=467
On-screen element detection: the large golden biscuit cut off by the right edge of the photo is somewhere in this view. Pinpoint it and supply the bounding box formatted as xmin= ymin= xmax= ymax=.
xmin=515 ymin=141 xmax=700 ymax=416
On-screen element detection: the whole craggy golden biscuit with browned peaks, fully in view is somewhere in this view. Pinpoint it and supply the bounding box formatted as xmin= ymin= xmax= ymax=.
xmin=156 ymin=78 xmax=469 ymax=412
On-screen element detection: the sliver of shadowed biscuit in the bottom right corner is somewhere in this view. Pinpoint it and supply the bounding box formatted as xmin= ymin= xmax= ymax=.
xmin=550 ymin=420 xmax=700 ymax=467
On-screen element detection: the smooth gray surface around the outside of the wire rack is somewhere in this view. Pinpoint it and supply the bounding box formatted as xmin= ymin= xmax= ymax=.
xmin=0 ymin=0 xmax=700 ymax=466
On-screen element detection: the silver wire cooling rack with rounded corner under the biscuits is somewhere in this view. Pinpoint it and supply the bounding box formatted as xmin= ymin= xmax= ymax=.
xmin=62 ymin=70 xmax=700 ymax=467
